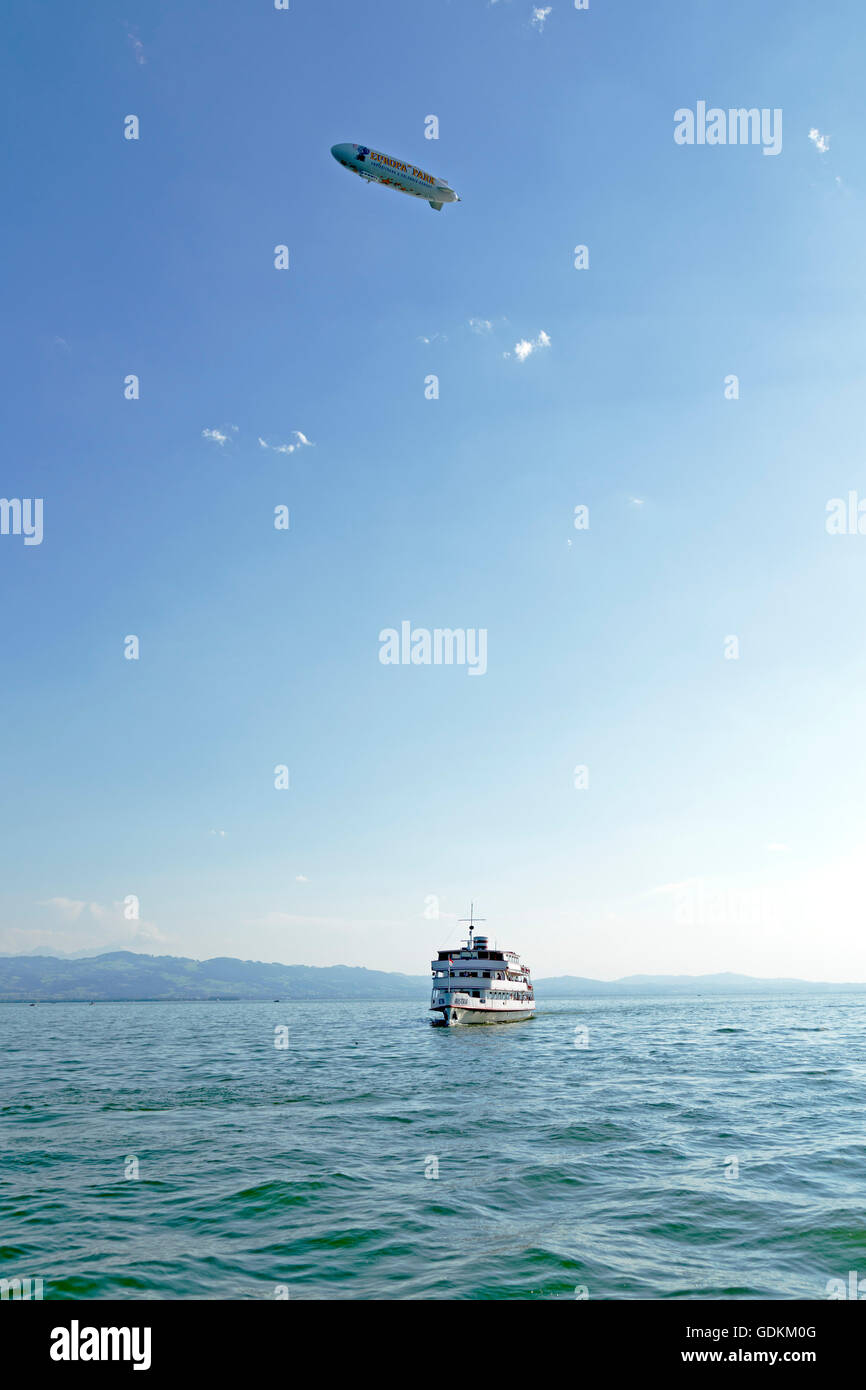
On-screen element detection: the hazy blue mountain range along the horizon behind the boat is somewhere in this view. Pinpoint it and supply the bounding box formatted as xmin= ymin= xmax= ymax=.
xmin=0 ymin=951 xmax=866 ymax=1004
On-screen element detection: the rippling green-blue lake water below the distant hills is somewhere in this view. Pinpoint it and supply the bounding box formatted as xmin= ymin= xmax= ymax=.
xmin=0 ymin=995 xmax=866 ymax=1298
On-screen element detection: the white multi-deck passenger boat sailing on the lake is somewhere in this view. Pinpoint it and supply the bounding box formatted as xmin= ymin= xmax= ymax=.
xmin=430 ymin=904 xmax=535 ymax=1027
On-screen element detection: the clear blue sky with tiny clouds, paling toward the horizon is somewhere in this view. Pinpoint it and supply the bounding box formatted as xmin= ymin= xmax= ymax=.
xmin=0 ymin=0 xmax=866 ymax=981
